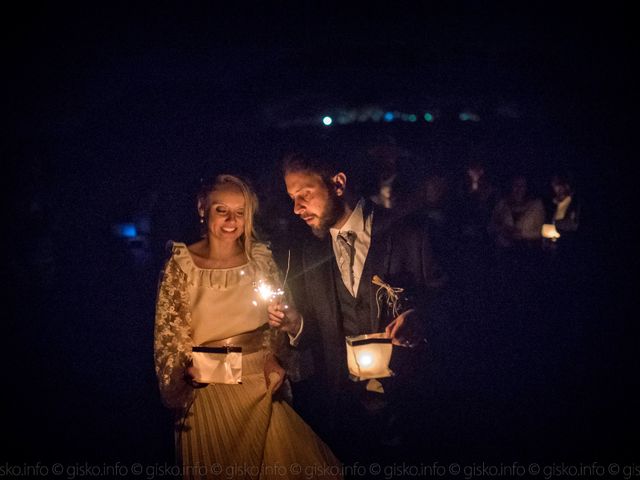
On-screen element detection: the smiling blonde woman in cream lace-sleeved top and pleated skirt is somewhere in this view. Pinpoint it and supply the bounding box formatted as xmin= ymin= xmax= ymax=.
xmin=154 ymin=175 xmax=341 ymax=478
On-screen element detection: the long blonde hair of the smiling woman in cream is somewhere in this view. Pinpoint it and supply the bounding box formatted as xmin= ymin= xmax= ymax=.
xmin=198 ymin=174 xmax=258 ymax=260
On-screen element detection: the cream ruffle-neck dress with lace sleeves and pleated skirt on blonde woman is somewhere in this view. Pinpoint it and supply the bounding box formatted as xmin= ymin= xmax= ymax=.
xmin=154 ymin=243 xmax=342 ymax=479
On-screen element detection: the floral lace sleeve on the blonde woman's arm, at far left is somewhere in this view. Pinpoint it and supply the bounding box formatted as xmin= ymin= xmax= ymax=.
xmin=154 ymin=258 xmax=193 ymax=409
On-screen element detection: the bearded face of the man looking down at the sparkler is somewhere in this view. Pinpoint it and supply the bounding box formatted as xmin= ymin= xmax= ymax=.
xmin=284 ymin=172 xmax=344 ymax=238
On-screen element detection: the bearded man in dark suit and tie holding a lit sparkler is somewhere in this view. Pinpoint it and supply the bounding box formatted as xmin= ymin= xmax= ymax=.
xmin=269 ymin=146 xmax=443 ymax=462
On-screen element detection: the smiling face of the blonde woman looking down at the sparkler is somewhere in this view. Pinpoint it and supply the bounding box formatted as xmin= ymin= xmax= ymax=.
xmin=201 ymin=185 xmax=245 ymax=241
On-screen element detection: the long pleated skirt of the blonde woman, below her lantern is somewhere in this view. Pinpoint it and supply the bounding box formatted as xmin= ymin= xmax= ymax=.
xmin=177 ymin=352 xmax=342 ymax=480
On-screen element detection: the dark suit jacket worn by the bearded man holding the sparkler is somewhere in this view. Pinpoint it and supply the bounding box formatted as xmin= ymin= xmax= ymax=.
xmin=298 ymin=200 xmax=442 ymax=393
